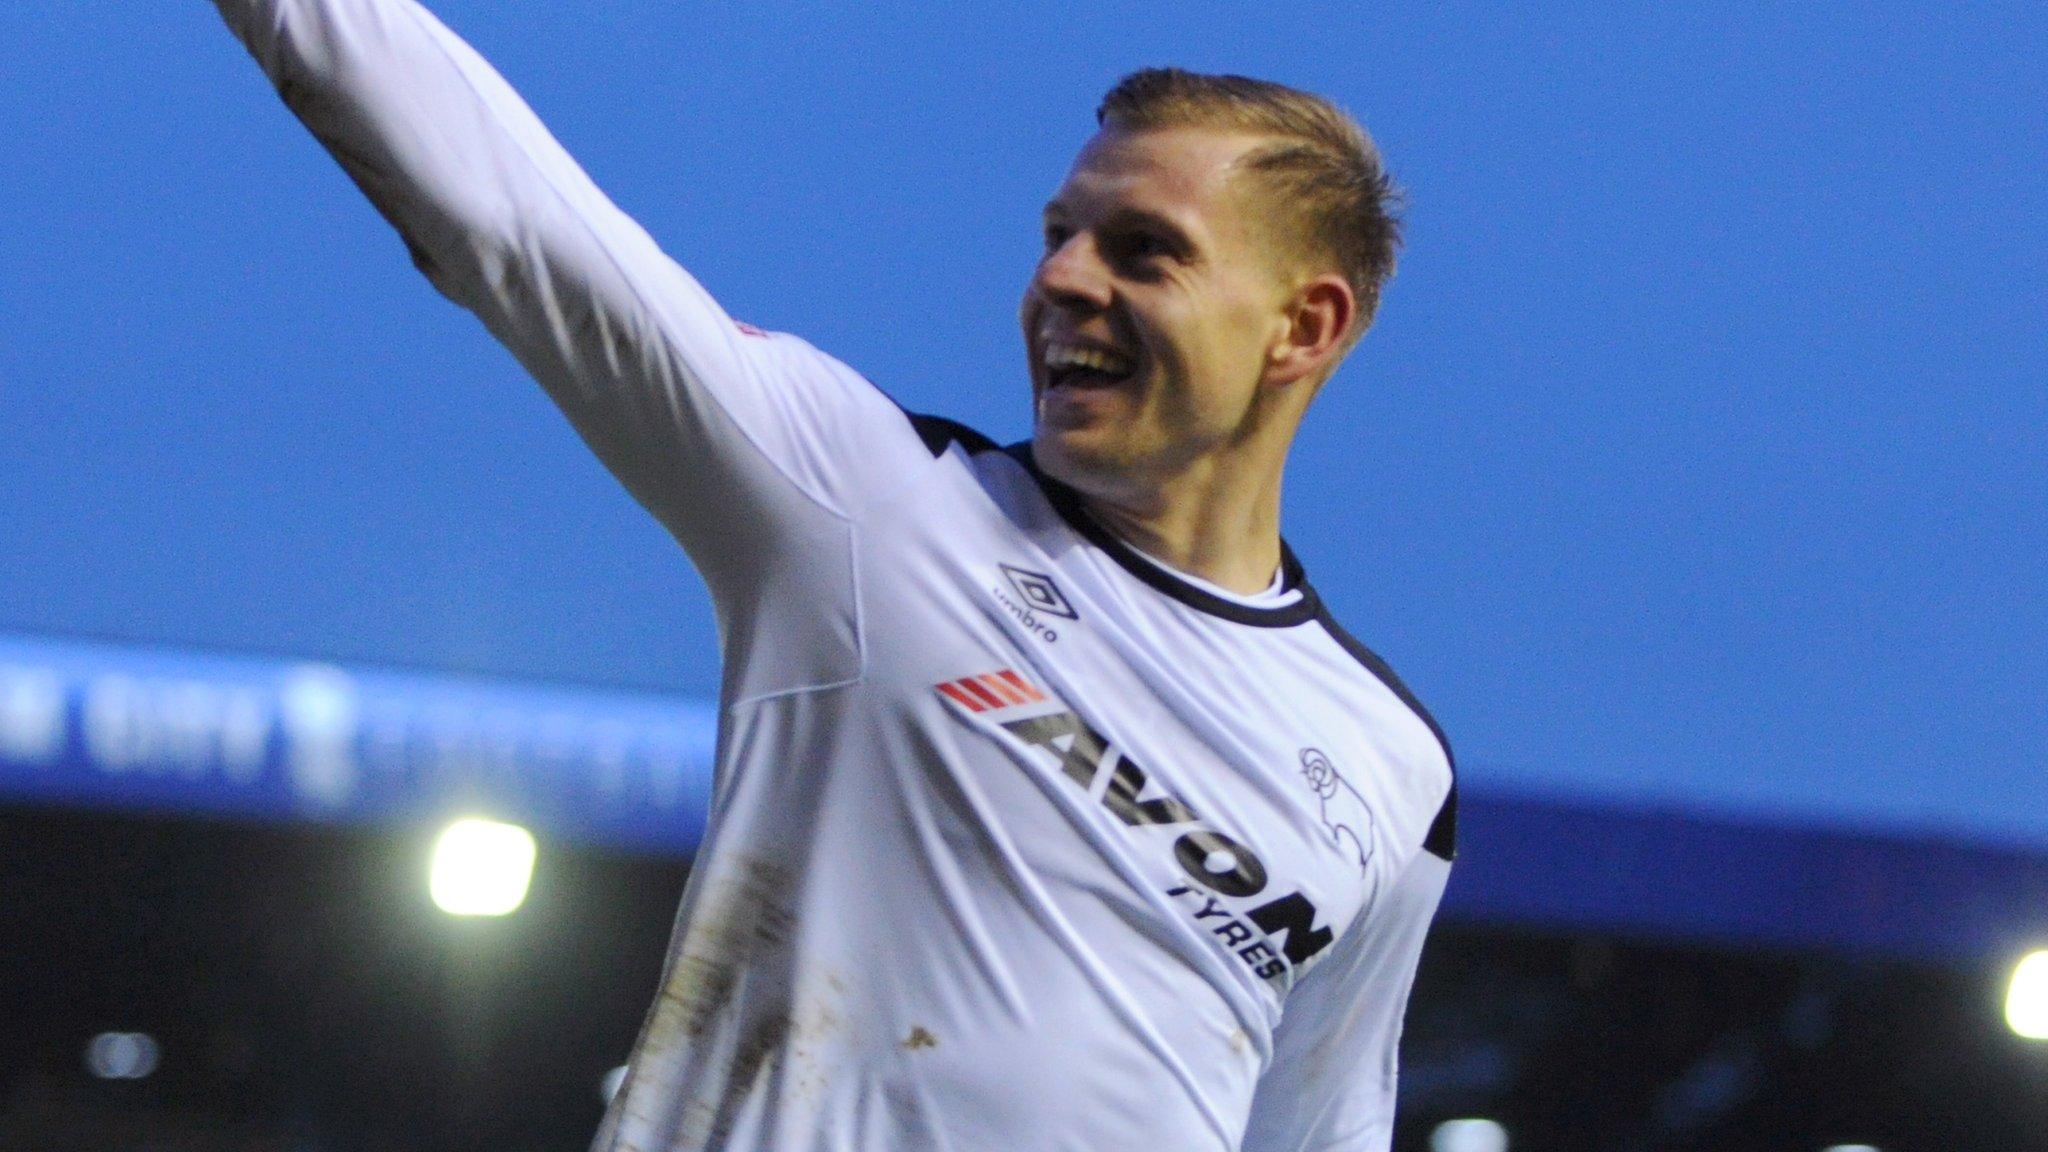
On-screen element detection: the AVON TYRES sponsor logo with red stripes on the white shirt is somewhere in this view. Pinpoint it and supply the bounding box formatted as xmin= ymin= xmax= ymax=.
xmin=938 ymin=668 xmax=1335 ymax=986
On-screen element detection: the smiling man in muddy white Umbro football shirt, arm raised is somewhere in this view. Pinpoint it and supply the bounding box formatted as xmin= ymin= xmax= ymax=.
xmin=219 ymin=0 xmax=1454 ymax=1152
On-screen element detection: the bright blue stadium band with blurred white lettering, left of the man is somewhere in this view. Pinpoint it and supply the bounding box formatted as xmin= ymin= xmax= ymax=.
xmin=0 ymin=635 xmax=715 ymax=853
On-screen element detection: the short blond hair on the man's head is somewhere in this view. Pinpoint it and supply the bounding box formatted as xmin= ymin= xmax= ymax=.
xmin=1096 ymin=68 xmax=1401 ymax=332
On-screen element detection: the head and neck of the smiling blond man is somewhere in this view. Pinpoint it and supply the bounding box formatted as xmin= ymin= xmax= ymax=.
xmin=1024 ymin=96 xmax=1397 ymax=590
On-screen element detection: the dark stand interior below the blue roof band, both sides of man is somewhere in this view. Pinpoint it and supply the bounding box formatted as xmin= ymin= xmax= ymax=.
xmin=0 ymin=810 xmax=2048 ymax=1152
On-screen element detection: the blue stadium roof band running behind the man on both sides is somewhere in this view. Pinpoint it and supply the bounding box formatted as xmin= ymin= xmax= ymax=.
xmin=0 ymin=633 xmax=2048 ymax=959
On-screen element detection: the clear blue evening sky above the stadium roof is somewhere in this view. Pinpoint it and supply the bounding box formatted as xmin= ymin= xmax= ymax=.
xmin=0 ymin=0 xmax=2048 ymax=845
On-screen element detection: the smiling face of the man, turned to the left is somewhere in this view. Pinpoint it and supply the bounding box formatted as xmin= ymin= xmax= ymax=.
xmin=1022 ymin=129 xmax=1286 ymax=500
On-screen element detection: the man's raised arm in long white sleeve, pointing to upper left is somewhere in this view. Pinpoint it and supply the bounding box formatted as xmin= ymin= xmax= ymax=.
xmin=217 ymin=0 xmax=930 ymax=611
